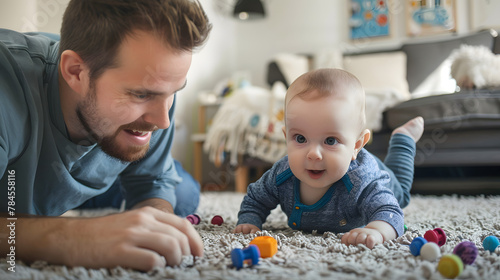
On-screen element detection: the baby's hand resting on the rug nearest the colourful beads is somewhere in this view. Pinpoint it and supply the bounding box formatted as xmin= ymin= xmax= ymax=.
xmin=341 ymin=221 xmax=396 ymax=249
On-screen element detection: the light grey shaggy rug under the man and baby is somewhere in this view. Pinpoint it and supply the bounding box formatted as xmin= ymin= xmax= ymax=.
xmin=0 ymin=192 xmax=500 ymax=279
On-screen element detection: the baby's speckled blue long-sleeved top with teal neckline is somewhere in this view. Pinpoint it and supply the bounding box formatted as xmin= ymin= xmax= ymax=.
xmin=238 ymin=149 xmax=404 ymax=236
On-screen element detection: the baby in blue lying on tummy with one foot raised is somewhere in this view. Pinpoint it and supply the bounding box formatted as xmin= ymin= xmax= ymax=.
xmin=234 ymin=69 xmax=424 ymax=248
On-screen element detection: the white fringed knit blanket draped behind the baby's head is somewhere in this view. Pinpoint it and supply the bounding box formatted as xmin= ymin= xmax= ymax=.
xmin=203 ymin=87 xmax=286 ymax=166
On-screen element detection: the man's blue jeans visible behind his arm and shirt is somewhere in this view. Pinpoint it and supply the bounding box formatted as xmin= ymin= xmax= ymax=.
xmin=78 ymin=160 xmax=200 ymax=217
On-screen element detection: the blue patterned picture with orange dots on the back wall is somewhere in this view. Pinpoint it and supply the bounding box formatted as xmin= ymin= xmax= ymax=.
xmin=349 ymin=0 xmax=390 ymax=40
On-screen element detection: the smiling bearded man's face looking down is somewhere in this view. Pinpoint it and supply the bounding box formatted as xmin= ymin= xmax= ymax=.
xmin=77 ymin=31 xmax=192 ymax=162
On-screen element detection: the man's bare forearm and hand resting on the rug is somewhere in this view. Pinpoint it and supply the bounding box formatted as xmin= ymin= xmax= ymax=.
xmin=2 ymin=207 xmax=203 ymax=271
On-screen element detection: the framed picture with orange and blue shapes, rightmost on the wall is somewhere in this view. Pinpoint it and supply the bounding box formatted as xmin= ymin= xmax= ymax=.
xmin=406 ymin=0 xmax=456 ymax=36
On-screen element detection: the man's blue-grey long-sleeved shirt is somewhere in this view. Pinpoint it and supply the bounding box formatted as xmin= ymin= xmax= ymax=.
xmin=0 ymin=29 xmax=181 ymax=216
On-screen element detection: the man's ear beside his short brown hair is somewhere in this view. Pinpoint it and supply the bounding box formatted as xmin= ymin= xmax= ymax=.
xmin=59 ymin=50 xmax=89 ymax=94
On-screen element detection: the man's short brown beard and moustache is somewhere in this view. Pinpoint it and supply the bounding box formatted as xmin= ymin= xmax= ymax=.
xmin=76 ymin=82 xmax=158 ymax=162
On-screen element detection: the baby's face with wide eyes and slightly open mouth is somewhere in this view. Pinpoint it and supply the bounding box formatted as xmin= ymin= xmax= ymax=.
xmin=285 ymin=92 xmax=361 ymax=188
